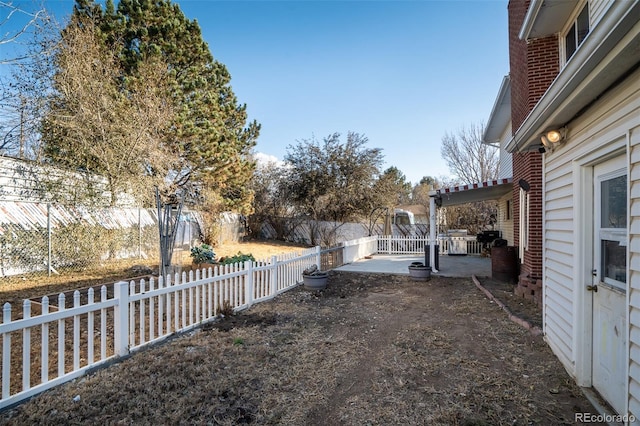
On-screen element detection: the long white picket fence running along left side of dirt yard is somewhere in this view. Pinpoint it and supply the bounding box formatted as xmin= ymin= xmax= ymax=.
xmin=0 ymin=247 xmax=320 ymax=409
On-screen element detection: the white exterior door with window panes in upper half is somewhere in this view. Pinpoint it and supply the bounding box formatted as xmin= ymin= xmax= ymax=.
xmin=589 ymin=157 xmax=628 ymax=413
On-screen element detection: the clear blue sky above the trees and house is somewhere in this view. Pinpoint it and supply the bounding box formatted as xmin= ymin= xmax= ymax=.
xmin=5 ymin=0 xmax=509 ymax=183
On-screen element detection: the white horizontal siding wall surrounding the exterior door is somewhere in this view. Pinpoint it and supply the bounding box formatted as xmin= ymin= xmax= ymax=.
xmin=543 ymin=66 xmax=640 ymax=418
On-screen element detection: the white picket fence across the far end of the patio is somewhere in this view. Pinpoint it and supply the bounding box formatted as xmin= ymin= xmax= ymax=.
xmin=378 ymin=235 xmax=482 ymax=255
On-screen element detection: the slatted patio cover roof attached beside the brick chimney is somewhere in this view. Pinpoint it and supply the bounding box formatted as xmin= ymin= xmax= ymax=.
xmin=429 ymin=178 xmax=513 ymax=207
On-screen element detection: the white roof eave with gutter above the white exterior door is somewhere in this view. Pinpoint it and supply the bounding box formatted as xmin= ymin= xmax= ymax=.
xmin=506 ymin=0 xmax=640 ymax=152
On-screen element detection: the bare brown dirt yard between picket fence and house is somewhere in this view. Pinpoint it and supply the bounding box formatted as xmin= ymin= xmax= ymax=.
xmin=0 ymin=272 xmax=595 ymax=425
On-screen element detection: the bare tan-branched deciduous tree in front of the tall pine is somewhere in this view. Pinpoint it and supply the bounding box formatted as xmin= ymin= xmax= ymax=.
xmin=44 ymin=21 xmax=178 ymax=205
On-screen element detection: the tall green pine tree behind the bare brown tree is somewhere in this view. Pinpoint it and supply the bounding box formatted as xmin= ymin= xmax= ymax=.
xmin=42 ymin=0 xmax=260 ymax=212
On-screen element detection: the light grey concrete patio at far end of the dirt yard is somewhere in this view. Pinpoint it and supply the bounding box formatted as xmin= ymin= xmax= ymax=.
xmin=336 ymin=254 xmax=491 ymax=277
